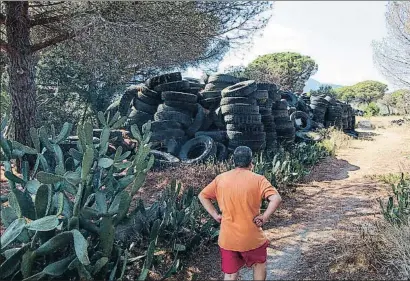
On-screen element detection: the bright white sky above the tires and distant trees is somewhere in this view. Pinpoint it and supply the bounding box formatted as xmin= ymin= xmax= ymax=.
xmin=185 ymin=1 xmax=391 ymax=88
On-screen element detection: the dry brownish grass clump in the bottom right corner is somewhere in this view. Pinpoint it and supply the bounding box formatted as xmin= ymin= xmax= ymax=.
xmin=362 ymin=222 xmax=410 ymax=279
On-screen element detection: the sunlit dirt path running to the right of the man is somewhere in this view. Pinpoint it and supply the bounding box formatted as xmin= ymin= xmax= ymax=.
xmin=190 ymin=121 xmax=410 ymax=280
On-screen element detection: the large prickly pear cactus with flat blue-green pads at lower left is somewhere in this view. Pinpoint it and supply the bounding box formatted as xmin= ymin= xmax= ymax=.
xmin=0 ymin=112 xmax=154 ymax=280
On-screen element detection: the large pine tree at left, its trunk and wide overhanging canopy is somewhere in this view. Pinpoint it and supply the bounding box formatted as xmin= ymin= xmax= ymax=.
xmin=0 ymin=1 xmax=272 ymax=143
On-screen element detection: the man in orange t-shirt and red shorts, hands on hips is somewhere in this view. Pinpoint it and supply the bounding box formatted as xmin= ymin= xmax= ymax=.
xmin=198 ymin=146 xmax=282 ymax=280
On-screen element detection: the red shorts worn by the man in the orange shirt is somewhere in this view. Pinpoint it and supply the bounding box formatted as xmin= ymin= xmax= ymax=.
xmin=219 ymin=241 xmax=270 ymax=274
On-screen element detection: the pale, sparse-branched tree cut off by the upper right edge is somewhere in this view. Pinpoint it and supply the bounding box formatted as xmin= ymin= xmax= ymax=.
xmin=373 ymin=1 xmax=410 ymax=88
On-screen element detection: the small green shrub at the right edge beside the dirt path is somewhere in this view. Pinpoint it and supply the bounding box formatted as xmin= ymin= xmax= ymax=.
xmin=379 ymin=174 xmax=410 ymax=226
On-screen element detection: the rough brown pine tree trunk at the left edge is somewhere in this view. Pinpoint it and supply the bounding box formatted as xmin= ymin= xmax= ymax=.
xmin=5 ymin=1 xmax=37 ymax=145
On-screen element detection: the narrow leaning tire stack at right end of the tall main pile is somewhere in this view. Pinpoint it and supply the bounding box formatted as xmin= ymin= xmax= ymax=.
xmin=272 ymin=99 xmax=296 ymax=145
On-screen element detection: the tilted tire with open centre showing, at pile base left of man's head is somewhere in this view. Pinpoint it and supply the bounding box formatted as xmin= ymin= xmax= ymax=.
xmin=179 ymin=136 xmax=217 ymax=164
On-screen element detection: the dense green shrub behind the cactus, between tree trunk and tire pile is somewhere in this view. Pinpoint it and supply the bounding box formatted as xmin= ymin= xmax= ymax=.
xmin=36 ymin=47 xmax=125 ymax=129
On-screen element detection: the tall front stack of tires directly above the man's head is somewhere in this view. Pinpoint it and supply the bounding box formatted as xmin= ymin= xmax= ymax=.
xmin=221 ymin=80 xmax=266 ymax=152
